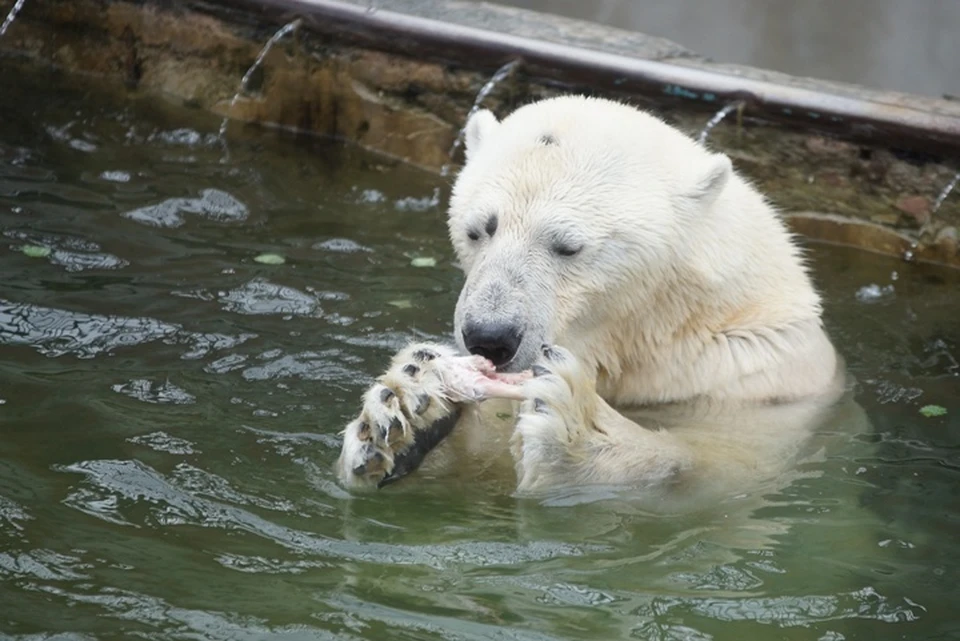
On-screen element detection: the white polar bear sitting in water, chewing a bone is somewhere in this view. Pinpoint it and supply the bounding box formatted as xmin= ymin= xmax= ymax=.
xmin=336 ymin=96 xmax=844 ymax=504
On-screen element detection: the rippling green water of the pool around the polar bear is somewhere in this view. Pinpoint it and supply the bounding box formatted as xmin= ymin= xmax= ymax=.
xmin=0 ymin=66 xmax=960 ymax=641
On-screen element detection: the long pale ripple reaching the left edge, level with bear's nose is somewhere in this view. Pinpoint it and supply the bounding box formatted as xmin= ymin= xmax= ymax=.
xmin=0 ymin=299 xmax=255 ymax=359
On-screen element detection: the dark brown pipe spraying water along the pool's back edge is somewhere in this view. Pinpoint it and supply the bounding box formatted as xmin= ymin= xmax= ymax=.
xmin=199 ymin=0 xmax=960 ymax=155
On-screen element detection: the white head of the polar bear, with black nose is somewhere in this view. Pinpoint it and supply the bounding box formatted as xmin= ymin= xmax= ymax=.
xmin=449 ymin=97 xmax=732 ymax=371
